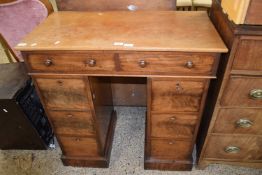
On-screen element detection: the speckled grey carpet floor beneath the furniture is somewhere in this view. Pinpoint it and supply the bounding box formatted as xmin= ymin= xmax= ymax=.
xmin=0 ymin=107 xmax=262 ymax=175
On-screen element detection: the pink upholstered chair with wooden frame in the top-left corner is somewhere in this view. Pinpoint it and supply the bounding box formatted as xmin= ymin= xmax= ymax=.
xmin=0 ymin=0 xmax=53 ymax=62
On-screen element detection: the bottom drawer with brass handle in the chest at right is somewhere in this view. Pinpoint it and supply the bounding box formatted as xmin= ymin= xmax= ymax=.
xmin=205 ymin=135 xmax=262 ymax=161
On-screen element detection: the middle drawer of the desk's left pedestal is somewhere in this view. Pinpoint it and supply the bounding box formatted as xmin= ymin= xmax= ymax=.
xmin=48 ymin=111 xmax=95 ymax=136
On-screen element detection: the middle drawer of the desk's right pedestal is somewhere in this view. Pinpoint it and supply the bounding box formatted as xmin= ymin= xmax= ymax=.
xmin=151 ymin=113 xmax=198 ymax=140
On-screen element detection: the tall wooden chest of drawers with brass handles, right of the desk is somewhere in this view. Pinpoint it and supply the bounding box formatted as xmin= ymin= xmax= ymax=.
xmin=198 ymin=0 xmax=262 ymax=168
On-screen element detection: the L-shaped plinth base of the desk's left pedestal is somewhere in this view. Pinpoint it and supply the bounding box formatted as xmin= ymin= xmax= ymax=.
xmin=61 ymin=111 xmax=117 ymax=168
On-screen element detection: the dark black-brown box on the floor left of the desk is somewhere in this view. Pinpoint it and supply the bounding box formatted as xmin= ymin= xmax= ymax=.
xmin=0 ymin=63 xmax=54 ymax=150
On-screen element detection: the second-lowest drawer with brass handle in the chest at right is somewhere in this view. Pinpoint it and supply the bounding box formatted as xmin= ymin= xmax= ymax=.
xmin=213 ymin=109 xmax=262 ymax=135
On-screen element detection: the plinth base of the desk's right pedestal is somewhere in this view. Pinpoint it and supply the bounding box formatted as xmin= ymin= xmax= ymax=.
xmin=144 ymin=159 xmax=193 ymax=171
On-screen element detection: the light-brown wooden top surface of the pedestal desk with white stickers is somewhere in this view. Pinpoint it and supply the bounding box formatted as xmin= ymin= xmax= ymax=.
xmin=16 ymin=11 xmax=227 ymax=52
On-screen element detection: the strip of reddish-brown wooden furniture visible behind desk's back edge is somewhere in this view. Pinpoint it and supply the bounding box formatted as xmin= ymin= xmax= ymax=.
xmin=56 ymin=0 xmax=176 ymax=11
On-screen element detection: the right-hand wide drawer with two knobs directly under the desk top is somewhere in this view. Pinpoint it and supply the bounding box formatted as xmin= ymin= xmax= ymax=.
xmin=120 ymin=53 xmax=215 ymax=75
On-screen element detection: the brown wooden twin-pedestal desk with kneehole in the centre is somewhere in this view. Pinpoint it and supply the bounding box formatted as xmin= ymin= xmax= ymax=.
xmin=16 ymin=11 xmax=227 ymax=170
